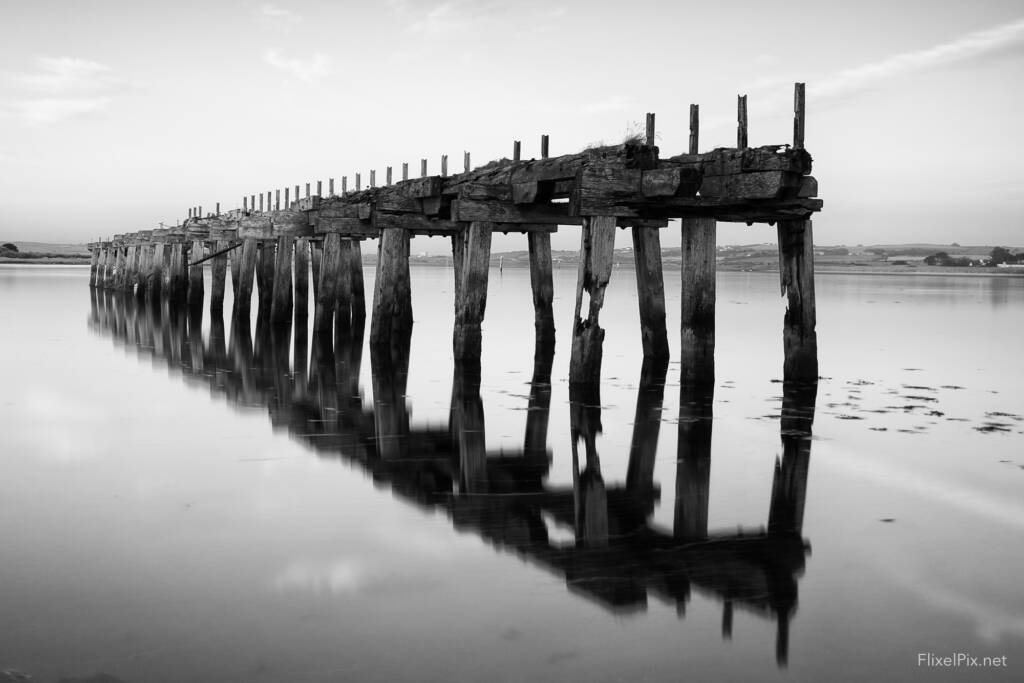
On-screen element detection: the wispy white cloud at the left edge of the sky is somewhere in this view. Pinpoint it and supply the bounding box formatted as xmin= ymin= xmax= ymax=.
xmin=5 ymin=56 xmax=137 ymax=125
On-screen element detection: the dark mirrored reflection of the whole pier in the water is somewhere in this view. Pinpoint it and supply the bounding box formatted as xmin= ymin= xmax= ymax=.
xmin=91 ymin=290 xmax=816 ymax=664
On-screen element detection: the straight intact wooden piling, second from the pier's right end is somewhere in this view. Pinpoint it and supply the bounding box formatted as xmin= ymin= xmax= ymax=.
xmin=679 ymin=218 xmax=716 ymax=385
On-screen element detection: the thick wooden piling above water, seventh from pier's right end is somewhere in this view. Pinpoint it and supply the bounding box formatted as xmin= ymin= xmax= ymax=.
xmin=370 ymin=228 xmax=413 ymax=345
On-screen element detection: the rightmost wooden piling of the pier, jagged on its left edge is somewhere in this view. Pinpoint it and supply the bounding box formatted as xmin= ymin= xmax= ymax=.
xmin=778 ymin=220 xmax=818 ymax=383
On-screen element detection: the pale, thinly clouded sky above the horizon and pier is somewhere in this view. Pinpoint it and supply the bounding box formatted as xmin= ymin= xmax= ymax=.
xmin=0 ymin=0 xmax=1024 ymax=253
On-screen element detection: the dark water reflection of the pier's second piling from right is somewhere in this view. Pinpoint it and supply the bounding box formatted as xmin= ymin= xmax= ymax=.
xmin=673 ymin=384 xmax=715 ymax=541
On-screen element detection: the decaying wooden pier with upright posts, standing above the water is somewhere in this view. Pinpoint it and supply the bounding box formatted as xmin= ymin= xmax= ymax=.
xmin=89 ymin=83 xmax=822 ymax=386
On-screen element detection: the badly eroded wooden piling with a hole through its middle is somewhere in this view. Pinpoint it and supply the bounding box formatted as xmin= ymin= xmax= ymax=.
xmin=569 ymin=216 xmax=615 ymax=384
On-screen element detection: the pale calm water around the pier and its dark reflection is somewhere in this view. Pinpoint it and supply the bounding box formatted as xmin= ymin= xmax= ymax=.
xmin=0 ymin=260 xmax=1024 ymax=683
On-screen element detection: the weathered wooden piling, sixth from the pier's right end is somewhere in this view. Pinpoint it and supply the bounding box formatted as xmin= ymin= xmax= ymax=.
xmin=453 ymin=222 xmax=494 ymax=362
